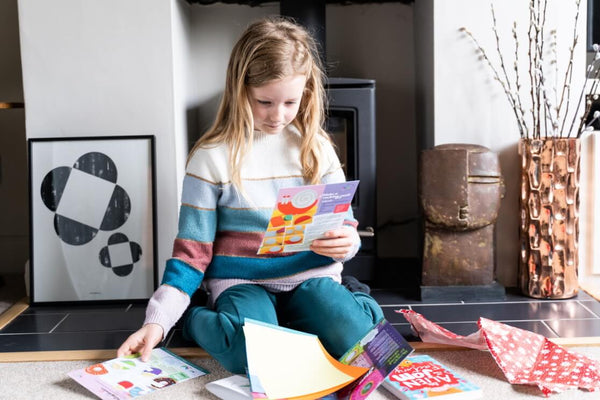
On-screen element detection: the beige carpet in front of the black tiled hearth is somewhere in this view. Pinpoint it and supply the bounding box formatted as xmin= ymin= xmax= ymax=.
xmin=0 ymin=347 xmax=600 ymax=400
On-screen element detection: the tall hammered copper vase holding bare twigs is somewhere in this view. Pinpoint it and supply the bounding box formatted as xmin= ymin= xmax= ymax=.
xmin=519 ymin=138 xmax=581 ymax=299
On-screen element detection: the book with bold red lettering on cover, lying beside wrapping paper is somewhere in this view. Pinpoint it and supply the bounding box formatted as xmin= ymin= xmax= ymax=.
xmin=383 ymin=355 xmax=483 ymax=400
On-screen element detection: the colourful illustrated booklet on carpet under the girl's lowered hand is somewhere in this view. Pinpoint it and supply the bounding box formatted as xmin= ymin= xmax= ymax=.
xmin=68 ymin=348 xmax=208 ymax=400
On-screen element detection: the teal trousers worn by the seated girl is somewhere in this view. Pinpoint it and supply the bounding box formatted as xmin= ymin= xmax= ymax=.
xmin=183 ymin=278 xmax=383 ymax=374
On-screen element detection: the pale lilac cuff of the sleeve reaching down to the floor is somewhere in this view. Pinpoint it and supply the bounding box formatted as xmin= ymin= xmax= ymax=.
xmin=144 ymin=285 xmax=190 ymax=339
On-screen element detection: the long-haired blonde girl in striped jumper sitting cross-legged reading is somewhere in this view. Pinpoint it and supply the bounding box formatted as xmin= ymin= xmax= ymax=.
xmin=118 ymin=14 xmax=383 ymax=373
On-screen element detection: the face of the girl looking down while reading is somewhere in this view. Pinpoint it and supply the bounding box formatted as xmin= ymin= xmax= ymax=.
xmin=249 ymin=75 xmax=306 ymax=134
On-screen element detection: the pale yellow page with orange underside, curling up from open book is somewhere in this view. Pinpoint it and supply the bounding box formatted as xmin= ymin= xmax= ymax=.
xmin=244 ymin=319 xmax=367 ymax=399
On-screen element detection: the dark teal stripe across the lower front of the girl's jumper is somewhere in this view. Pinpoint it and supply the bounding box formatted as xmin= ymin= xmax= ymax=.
xmin=206 ymin=251 xmax=334 ymax=279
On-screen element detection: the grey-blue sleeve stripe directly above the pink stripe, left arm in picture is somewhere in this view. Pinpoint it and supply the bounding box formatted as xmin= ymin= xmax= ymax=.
xmin=177 ymin=205 xmax=217 ymax=243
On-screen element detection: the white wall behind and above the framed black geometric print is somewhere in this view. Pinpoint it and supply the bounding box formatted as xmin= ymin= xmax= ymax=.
xmin=19 ymin=0 xmax=182 ymax=280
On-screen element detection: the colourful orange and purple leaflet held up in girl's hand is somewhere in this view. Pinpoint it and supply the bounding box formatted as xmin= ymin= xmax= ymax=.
xmin=257 ymin=181 xmax=358 ymax=254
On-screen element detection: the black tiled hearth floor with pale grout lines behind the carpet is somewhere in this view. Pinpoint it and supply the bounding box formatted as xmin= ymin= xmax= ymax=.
xmin=0 ymin=288 xmax=600 ymax=353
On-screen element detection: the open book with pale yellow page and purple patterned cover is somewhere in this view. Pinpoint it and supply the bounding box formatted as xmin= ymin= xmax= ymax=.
xmin=240 ymin=319 xmax=413 ymax=400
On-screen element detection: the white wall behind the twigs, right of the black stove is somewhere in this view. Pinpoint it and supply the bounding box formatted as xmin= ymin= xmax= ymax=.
xmin=424 ymin=0 xmax=586 ymax=286
